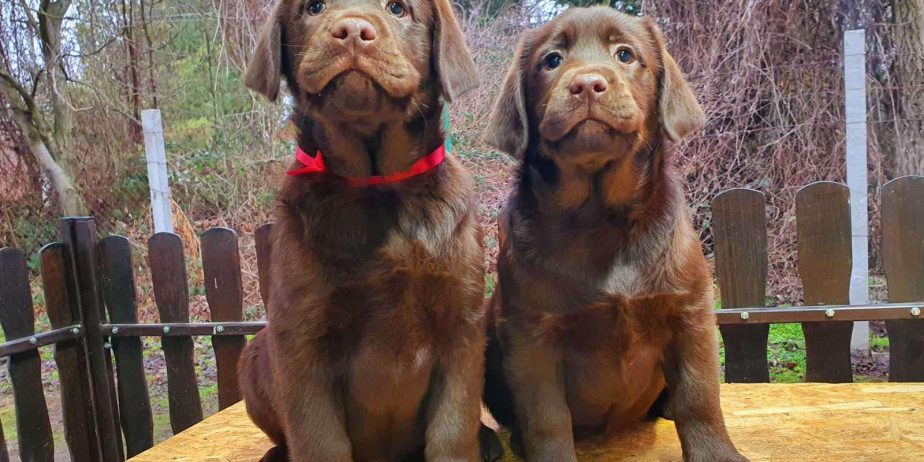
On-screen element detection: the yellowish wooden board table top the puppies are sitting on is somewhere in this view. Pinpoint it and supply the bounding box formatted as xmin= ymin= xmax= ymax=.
xmin=131 ymin=383 xmax=924 ymax=462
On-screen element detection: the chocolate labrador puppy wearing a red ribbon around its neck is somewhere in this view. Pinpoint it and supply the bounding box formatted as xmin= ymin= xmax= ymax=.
xmin=240 ymin=0 xmax=494 ymax=462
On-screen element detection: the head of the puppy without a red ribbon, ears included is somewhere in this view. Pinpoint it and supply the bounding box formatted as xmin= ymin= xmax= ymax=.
xmin=486 ymin=7 xmax=704 ymax=163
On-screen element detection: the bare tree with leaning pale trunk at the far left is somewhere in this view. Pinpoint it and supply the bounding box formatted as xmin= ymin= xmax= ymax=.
xmin=0 ymin=0 xmax=87 ymax=215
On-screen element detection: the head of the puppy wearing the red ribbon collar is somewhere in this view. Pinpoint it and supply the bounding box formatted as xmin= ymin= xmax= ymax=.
xmin=244 ymin=0 xmax=477 ymax=120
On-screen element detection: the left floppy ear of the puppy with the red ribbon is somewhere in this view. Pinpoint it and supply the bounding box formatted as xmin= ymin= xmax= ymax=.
xmin=244 ymin=1 xmax=282 ymax=101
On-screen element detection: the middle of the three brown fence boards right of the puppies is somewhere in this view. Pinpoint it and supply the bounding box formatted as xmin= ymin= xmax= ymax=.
xmin=796 ymin=181 xmax=853 ymax=383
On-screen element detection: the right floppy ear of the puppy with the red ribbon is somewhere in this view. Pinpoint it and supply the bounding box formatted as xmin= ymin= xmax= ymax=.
xmin=433 ymin=0 xmax=478 ymax=102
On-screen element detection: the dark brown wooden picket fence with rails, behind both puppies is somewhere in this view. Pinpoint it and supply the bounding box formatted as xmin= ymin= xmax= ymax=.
xmin=0 ymin=177 xmax=924 ymax=462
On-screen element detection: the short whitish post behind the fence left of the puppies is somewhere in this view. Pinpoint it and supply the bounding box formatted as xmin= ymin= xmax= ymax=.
xmin=141 ymin=109 xmax=173 ymax=233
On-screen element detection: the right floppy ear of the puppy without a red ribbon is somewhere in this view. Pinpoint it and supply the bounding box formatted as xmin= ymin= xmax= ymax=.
xmin=644 ymin=17 xmax=706 ymax=142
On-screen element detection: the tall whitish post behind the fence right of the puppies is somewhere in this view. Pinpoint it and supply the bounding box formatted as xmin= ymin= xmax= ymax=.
xmin=844 ymin=29 xmax=869 ymax=356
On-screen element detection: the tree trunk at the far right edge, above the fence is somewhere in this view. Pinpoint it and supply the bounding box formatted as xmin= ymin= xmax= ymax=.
xmin=890 ymin=0 xmax=924 ymax=176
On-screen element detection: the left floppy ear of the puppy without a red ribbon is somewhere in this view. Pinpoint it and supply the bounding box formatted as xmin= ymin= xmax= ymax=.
xmin=484 ymin=36 xmax=529 ymax=159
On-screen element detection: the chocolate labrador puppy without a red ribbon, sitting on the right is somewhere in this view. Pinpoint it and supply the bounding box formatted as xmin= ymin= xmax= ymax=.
xmin=485 ymin=7 xmax=746 ymax=462
